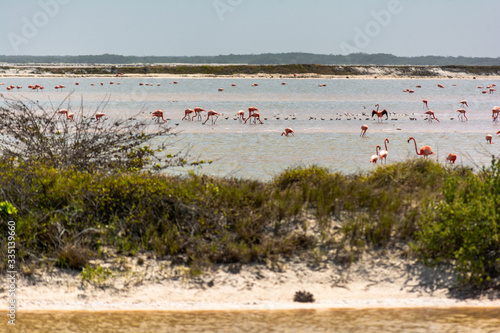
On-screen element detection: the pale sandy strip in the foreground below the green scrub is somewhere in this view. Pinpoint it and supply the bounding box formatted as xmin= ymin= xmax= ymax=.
xmin=0 ymin=249 xmax=500 ymax=311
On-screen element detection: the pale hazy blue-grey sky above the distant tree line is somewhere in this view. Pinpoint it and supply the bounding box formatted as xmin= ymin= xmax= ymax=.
xmin=0 ymin=0 xmax=500 ymax=57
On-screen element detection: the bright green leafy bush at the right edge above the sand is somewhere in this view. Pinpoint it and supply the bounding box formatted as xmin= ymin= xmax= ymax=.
xmin=417 ymin=159 xmax=500 ymax=286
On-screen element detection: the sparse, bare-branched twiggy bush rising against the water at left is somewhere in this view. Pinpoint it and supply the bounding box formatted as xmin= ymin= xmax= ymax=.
xmin=0 ymin=96 xmax=192 ymax=171
